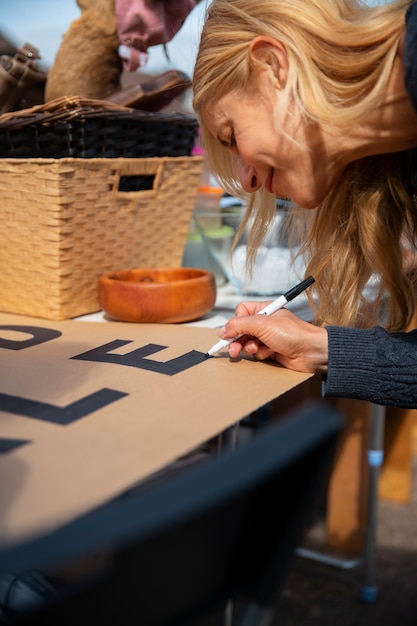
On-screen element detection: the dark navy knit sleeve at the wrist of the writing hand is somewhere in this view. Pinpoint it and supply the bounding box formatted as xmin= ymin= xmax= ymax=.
xmin=322 ymin=326 xmax=417 ymax=408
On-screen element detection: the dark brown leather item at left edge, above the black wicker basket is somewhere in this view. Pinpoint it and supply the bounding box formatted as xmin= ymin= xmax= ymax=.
xmin=0 ymin=43 xmax=47 ymax=113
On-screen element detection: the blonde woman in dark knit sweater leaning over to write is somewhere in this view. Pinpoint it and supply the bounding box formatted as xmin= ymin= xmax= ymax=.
xmin=193 ymin=0 xmax=417 ymax=407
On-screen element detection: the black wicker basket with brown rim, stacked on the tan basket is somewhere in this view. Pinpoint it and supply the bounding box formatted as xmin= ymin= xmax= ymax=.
xmin=0 ymin=96 xmax=198 ymax=158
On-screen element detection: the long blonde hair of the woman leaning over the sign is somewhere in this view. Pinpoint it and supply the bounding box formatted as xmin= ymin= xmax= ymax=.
xmin=193 ymin=0 xmax=417 ymax=330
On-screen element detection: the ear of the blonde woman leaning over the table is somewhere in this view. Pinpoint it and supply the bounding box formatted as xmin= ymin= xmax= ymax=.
xmin=249 ymin=35 xmax=289 ymax=89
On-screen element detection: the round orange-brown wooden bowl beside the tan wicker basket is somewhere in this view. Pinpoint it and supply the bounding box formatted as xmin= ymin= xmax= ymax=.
xmin=99 ymin=267 xmax=216 ymax=324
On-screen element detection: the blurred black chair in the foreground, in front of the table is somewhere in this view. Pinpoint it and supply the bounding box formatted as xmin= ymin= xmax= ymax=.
xmin=0 ymin=404 xmax=343 ymax=626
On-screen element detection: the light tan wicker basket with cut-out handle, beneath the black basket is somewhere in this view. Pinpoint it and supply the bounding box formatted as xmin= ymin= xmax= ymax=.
xmin=0 ymin=157 xmax=202 ymax=320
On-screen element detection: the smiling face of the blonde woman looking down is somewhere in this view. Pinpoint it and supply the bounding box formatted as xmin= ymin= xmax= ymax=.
xmin=202 ymin=79 xmax=338 ymax=209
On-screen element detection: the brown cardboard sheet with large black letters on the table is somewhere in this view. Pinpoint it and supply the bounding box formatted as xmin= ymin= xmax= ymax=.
xmin=0 ymin=314 xmax=311 ymax=544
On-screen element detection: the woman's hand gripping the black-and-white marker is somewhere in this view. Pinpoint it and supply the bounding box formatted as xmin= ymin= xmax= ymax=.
xmin=219 ymin=302 xmax=328 ymax=373
